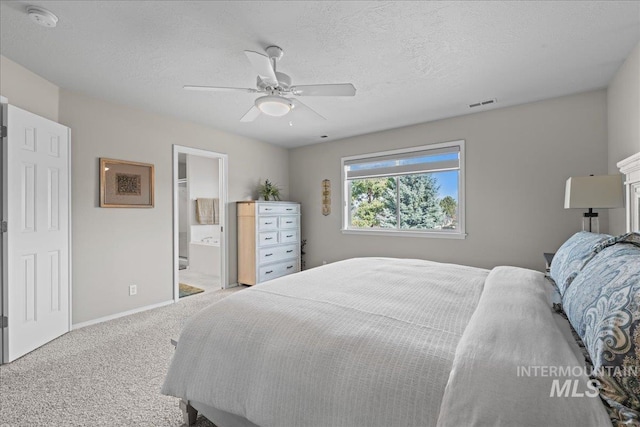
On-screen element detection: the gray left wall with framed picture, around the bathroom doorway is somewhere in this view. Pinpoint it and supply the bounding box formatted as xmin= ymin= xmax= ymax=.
xmin=60 ymin=90 xmax=289 ymax=323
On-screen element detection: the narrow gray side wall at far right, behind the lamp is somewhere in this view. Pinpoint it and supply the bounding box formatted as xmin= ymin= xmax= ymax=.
xmin=607 ymin=43 xmax=640 ymax=234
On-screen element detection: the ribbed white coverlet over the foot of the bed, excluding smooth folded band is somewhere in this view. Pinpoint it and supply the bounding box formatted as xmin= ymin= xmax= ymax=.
xmin=162 ymin=258 xmax=488 ymax=427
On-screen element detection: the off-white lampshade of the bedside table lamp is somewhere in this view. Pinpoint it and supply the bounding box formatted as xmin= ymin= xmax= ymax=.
xmin=564 ymin=175 xmax=623 ymax=209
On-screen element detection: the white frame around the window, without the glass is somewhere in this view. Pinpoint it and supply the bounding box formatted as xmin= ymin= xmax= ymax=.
xmin=341 ymin=140 xmax=467 ymax=239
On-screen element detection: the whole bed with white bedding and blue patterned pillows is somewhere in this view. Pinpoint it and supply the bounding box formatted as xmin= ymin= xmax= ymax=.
xmin=162 ymin=152 xmax=640 ymax=427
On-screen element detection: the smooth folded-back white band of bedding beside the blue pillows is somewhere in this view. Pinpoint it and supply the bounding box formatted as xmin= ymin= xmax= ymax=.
xmin=438 ymin=267 xmax=611 ymax=427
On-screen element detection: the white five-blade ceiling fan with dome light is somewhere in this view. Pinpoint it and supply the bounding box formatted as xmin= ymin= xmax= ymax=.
xmin=184 ymin=46 xmax=356 ymax=122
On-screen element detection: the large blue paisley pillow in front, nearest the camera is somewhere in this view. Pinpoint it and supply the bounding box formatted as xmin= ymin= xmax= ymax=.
xmin=562 ymin=241 xmax=640 ymax=425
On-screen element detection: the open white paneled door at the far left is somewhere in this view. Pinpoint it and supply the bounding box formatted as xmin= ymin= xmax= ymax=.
xmin=3 ymin=105 xmax=70 ymax=362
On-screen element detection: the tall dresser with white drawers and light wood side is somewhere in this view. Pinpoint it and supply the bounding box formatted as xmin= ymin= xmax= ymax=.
xmin=237 ymin=201 xmax=300 ymax=285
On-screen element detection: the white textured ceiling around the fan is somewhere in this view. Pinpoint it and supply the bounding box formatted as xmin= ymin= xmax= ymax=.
xmin=0 ymin=0 xmax=640 ymax=147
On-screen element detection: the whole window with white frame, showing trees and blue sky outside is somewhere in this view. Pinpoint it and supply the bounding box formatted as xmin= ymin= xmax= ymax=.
xmin=342 ymin=141 xmax=465 ymax=238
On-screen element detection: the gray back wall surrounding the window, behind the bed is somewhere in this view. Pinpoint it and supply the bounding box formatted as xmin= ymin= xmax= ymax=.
xmin=289 ymin=90 xmax=608 ymax=270
